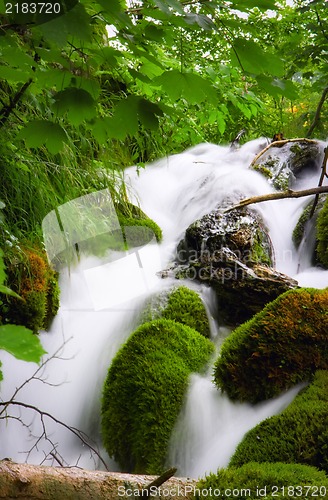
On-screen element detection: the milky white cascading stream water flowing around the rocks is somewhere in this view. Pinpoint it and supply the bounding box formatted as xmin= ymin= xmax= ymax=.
xmin=0 ymin=139 xmax=328 ymax=477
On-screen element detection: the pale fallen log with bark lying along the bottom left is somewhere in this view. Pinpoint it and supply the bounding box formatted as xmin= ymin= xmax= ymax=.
xmin=0 ymin=460 xmax=197 ymax=500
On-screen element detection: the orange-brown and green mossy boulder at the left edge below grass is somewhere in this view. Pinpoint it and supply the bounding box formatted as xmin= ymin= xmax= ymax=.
xmin=0 ymin=248 xmax=60 ymax=333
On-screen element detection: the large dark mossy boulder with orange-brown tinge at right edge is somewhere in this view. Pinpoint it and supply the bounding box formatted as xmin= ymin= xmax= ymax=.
xmin=214 ymin=288 xmax=328 ymax=403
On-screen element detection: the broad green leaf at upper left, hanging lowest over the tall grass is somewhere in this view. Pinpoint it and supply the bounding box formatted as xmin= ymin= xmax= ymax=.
xmin=17 ymin=120 xmax=67 ymax=154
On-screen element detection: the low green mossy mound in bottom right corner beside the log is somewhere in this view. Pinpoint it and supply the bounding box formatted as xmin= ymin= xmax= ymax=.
xmin=195 ymin=462 xmax=328 ymax=500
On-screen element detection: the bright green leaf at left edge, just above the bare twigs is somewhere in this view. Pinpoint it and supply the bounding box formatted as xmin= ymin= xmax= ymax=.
xmin=0 ymin=325 xmax=46 ymax=363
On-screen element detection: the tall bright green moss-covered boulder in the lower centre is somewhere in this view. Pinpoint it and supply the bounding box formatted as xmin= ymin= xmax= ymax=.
xmin=102 ymin=319 xmax=214 ymax=474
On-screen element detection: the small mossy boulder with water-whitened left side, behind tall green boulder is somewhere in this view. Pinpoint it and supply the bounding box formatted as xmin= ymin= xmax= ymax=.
xmin=140 ymin=286 xmax=210 ymax=337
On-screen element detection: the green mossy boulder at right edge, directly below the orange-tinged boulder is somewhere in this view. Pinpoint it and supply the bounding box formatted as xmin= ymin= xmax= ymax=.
xmin=230 ymin=371 xmax=328 ymax=472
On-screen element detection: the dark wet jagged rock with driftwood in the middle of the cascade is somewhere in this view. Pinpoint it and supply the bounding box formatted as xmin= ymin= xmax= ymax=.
xmin=166 ymin=208 xmax=297 ymax=325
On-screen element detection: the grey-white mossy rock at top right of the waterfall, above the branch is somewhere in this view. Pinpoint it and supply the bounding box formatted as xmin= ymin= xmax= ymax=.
xmin=252 ymin=139 xmax=324 ymax=190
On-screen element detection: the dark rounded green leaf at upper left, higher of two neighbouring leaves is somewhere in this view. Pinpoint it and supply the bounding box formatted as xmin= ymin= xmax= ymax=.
xmin=54 ymin=87 xmax=97 ymax=126
